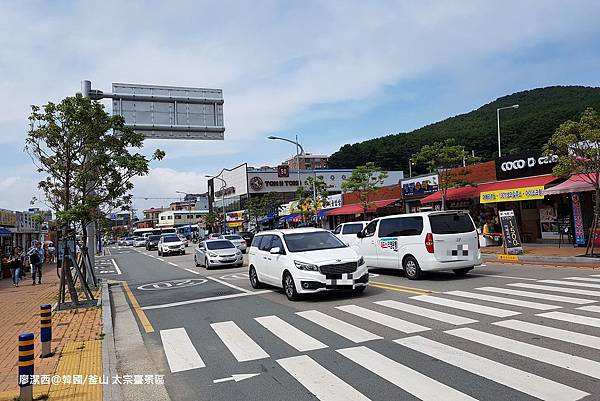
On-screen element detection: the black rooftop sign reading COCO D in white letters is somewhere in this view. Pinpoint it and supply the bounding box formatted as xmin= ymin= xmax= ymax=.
xmin=496 ymin=153 xmax=558 ymax=181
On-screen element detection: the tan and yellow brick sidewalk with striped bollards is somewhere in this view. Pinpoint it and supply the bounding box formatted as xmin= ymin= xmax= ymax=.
xmin=0 ymin=265 xmax=102 ymax=401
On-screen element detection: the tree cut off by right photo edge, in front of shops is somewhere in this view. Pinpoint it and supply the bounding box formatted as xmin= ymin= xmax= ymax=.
xmin=544 ymin=107 xmax=600 ymax=255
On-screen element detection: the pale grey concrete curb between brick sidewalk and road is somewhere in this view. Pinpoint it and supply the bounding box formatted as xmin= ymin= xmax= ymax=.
xmin=101 ymin=281 xmax=123 ymax=401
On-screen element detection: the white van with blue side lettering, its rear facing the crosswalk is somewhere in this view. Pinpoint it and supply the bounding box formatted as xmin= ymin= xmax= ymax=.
xmin=352 ymin=211 xmax=481 ymax=280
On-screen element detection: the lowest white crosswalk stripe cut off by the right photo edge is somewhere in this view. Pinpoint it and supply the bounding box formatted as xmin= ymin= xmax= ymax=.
xmin=445 ymin=327 xmax=600 ymax=379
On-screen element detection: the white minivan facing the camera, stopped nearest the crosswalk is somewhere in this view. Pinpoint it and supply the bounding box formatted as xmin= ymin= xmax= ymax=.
xmin=248 ymin=228 xmax=369 ymax=301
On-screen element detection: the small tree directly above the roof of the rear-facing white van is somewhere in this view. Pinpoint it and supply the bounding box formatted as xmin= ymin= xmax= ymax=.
xmin=412 ymin=139 xmax=478 ymax=210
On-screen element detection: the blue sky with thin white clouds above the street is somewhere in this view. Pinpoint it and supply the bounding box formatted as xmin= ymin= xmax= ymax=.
xmin=0 ymin=0 xmax=600 ymax=209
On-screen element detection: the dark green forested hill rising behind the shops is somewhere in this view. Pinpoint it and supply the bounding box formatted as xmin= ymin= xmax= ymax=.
xmin=329 ymin=86 xmax=600 ymax=171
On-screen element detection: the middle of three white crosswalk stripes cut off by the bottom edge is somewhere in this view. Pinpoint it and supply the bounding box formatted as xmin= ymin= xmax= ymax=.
xmin=337 ymin=346 xmax=475 ymax=401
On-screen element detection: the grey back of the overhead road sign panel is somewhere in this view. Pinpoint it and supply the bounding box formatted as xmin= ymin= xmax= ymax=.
xmin=110 ymin=83 xmax=225 ymax=140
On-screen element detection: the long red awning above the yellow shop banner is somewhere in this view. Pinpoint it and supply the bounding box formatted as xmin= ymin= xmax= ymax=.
xmin=421 ymin=175 xmax=556 ymax=203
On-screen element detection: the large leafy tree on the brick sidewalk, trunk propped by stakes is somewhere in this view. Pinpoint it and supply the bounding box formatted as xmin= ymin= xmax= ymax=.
xmin=25 ymin=95 xmax=164 ymax=303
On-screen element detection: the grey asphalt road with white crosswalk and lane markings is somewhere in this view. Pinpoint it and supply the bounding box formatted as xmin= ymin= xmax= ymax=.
xmin=97 ymin=246 xmax=600 ymax=401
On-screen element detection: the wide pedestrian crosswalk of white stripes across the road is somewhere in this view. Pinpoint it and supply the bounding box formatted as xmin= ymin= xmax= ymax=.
xmin=160 ymin=276 xmax=600 ymax=401
